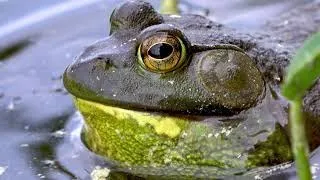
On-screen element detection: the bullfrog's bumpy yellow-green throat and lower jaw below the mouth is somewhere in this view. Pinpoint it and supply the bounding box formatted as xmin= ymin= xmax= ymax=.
xmin=75 ymin=98 xmax=291 ymax=176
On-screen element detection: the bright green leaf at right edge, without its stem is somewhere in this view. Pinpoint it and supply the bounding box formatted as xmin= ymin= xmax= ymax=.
xmin=282 ymin=32 xmax=320 ymax=100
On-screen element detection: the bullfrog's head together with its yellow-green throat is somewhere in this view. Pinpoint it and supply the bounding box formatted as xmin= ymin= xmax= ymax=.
xmin=64 ymin=1 xmax=288 ymax=177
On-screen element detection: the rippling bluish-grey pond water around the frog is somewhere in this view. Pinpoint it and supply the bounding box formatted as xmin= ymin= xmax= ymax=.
xmin=0 ymin=0 xmax=320 ymax=180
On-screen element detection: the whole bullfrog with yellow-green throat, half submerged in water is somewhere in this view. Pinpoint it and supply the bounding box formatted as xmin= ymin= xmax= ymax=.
xmin=63 ymin=0 xmax=320 ymax=179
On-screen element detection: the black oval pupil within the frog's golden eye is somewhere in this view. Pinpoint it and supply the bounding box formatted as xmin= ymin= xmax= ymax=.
xmin=148 ymin=43 xmax=173 ymax=59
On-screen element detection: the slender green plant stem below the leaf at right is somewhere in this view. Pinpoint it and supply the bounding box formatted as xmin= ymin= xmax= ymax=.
xmin=290 ymin=98 xmax=311 ymax=180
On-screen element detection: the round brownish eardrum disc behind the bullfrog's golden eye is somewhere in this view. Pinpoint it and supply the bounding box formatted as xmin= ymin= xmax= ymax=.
xmin=198 ymin=49 xmax=264 ymax=109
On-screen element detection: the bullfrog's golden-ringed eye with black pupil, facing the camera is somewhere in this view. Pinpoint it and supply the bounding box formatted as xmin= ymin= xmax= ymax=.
xmin=138 ymin=32 xmax=186 ymax=73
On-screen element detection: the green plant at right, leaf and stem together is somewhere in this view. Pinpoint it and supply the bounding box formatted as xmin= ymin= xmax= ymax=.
xmin=282 ymin=32 xmax=320 ymax=180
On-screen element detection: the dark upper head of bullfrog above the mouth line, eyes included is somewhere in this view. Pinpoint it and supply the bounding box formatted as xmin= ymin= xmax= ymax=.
xmin=64 ymin=1 xmax=264 ymax=114
